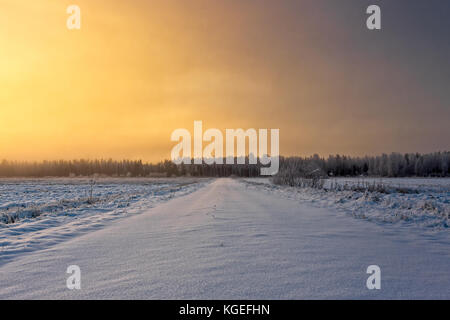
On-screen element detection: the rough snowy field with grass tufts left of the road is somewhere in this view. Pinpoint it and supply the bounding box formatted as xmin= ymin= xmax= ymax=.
xmin=0 ymin=178 xmax=208 ymax=265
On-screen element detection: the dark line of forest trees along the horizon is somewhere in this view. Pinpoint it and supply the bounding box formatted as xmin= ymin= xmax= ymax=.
xmin=0 ymin=151 xmax=450 ymax=177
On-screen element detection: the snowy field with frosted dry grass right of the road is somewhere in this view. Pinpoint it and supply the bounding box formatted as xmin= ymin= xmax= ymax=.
xmin=243 ymin=178 xmax=450 ymax=232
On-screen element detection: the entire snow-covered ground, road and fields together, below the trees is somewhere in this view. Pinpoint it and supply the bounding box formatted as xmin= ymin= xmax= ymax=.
xmin=0 ymin=178 xmax=450 ymax=299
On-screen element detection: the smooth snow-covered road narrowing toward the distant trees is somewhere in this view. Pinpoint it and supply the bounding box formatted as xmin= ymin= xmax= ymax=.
xmin=0 ymin=179 xmax=450 ymax=299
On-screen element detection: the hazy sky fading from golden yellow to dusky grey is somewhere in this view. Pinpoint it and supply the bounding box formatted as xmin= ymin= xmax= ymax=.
xmin=0 ymin=0 xmax=450 ymax=161
